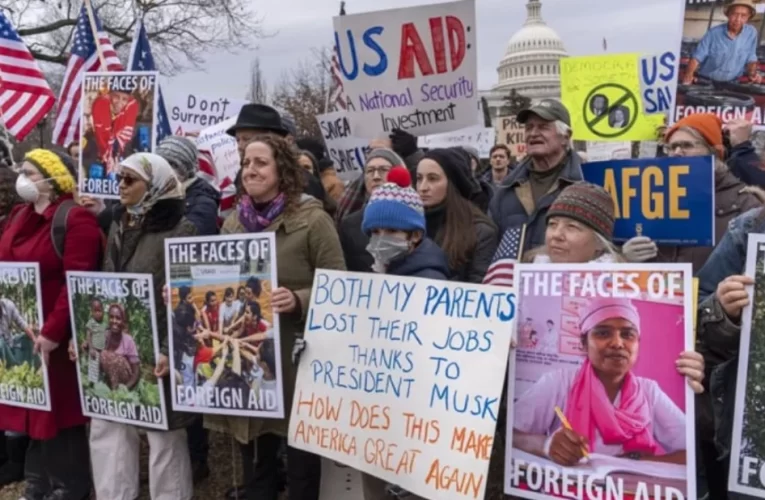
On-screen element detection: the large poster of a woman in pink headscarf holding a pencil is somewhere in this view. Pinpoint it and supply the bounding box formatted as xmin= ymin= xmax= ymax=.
xmin=505 ymin=263 xmax=696 ymax=500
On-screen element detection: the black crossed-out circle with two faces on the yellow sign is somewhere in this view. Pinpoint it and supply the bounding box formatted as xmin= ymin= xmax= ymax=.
xmin=582 ymin=83 xmax=640 ymax=139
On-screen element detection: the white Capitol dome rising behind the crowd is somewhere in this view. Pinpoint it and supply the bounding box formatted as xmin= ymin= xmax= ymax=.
xmin=480 ymin=0 xmax=568 ymax=121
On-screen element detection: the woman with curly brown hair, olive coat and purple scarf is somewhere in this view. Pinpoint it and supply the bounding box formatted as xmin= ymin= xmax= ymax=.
xmin=205 ymin=135 xmax=345 ymax=500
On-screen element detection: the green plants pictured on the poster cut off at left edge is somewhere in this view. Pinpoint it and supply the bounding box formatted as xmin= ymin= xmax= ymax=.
xmin=0 ymin=268 xmax=45 ymax=389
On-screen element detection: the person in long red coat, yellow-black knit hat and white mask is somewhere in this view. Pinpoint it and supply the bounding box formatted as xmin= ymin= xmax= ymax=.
xmin=0 ymin=149 xmax=102 ymax=500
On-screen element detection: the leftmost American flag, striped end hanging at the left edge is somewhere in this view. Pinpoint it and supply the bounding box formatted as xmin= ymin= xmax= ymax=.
xmin=0 ymin=11 xmax=56 ymax=141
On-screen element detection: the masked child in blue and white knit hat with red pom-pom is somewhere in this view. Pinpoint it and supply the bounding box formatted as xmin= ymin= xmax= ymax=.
xmin=361 ymin=167 xmax=449 ymax=280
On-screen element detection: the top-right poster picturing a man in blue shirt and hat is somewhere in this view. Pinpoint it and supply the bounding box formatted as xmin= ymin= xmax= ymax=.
xmin=672 ymin=1 xmax=765 ymax=127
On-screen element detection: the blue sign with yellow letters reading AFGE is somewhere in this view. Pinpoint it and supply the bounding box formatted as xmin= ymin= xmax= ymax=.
xmin=582 ymin=156 xmax=715 ymax=247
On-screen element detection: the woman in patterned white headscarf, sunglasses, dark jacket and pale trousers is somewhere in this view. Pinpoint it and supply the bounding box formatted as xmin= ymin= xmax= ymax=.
xmin=90 ymin=153 xmax=196 ymax=500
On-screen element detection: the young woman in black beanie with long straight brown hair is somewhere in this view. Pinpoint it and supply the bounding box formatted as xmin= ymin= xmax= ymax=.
xmin=417 ymin=149 xmax=497 ymax=283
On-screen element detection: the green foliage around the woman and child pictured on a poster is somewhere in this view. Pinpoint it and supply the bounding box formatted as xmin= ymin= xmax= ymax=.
xmin=72 ymin=278 xmax=160 ymax=408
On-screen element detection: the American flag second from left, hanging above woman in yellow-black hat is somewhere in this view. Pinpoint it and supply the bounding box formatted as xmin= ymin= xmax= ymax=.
xmin=53 ymin=2 xmax=123 ymax=146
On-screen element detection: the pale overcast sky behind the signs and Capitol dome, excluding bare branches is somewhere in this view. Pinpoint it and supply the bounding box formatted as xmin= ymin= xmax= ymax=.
xmin=164 ymin=0 xmax=684 ymax=98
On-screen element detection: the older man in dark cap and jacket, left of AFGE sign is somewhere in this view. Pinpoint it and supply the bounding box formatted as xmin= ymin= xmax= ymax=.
xmin=489 ymin=99 xmax=582 ymax=249
